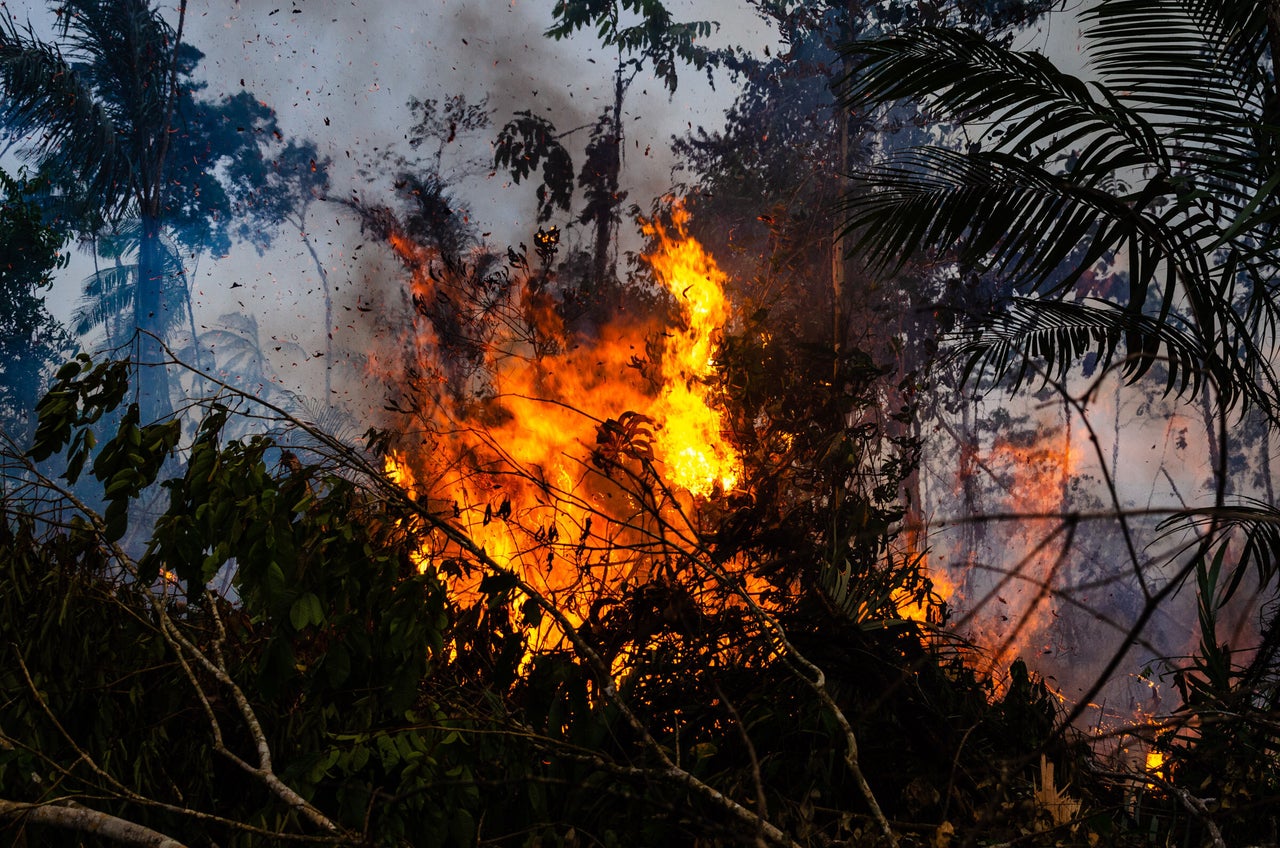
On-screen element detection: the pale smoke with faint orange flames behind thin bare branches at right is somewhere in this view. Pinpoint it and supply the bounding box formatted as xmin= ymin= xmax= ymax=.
xmin=922 ymin=366 xmax=1274 ymax=734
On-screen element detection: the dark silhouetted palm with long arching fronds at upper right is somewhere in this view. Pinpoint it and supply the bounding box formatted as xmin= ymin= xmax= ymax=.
xmin=846 ymin=0 xmax=1280 ymax=421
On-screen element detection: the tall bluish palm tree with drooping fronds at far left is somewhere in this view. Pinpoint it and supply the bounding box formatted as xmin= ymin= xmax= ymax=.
xmin=0 ymin=0 xmax=187 ymax=420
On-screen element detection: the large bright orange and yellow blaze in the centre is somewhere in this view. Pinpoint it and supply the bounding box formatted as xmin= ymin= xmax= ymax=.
xmin=385 ymin=202 xmax=740 ymax=649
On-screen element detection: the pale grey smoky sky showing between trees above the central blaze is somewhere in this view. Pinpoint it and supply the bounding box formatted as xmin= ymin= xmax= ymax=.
xmin=17 ymin=0 xmax=772 ymax=404
